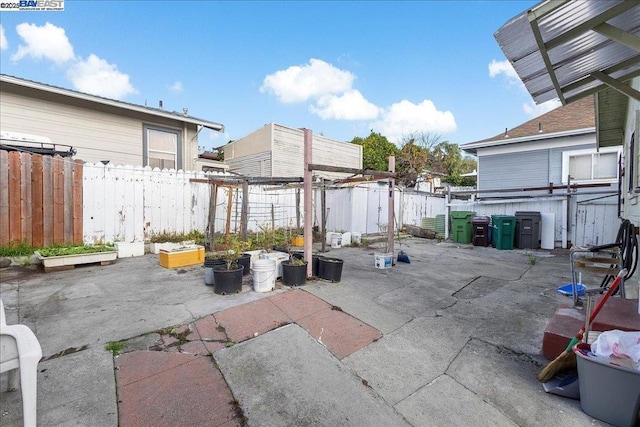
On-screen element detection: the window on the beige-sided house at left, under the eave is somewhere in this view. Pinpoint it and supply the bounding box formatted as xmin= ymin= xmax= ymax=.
xmin=143 ymin=125 xmax=182 ymax=169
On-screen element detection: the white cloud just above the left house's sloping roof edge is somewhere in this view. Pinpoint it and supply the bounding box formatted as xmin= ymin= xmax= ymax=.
xmin=67 ymin=54 xmax=137 ymax=99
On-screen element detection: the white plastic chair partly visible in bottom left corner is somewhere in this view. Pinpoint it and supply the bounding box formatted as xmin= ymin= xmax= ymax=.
xmin=0 ymin=299 xmax=42 ymax=427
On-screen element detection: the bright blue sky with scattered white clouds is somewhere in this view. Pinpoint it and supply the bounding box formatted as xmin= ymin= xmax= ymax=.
xmin=0 ymin=0 xmax=558 ymax=154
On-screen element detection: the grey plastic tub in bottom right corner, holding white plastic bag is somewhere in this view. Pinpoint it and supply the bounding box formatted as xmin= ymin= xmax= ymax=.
xmin=573 ymin=343 xmax=640 ymax=427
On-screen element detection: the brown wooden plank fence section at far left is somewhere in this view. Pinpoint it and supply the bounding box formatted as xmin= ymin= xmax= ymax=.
xmin=0 ymin=150 xmax=83 ymax=247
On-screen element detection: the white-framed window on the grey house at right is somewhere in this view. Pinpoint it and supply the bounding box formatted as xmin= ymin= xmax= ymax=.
xmin=562 ymin=147 xmax=622 ymax=183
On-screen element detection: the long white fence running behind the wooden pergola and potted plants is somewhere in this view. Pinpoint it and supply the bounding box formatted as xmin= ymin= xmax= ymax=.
xmin=83 ymin=163 xmax=445 ymax=243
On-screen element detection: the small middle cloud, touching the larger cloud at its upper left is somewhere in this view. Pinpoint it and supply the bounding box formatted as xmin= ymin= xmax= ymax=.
xmin=309 ymin=90 xmax=380 ymax=120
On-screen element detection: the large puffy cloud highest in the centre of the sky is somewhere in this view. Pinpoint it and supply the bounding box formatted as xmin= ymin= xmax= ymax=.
xmin=260 ymin=58 xmax=355 ymax=104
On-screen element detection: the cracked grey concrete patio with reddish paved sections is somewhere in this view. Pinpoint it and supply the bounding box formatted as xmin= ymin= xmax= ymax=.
xmin=0 ymin=238 xmax=603 ymax=426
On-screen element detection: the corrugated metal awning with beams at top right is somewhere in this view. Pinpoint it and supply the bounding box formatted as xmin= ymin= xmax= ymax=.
xmin=494 ymin=0 xmax=640 ymax=104
